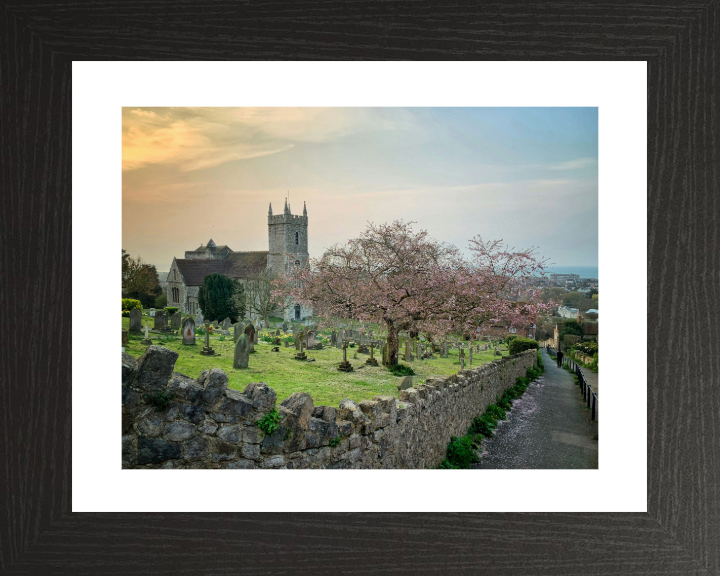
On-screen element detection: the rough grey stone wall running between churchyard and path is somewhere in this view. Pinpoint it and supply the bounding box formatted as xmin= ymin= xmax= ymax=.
xmin=122 ymin=346 xmax=537 ymax=468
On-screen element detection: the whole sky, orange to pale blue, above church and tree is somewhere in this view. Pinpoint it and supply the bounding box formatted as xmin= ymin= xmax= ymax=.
xmin=122 ymin=107 xmax=598 ymax=272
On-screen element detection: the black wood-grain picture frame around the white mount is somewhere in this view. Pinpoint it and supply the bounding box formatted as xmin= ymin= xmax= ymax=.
xmin=0 ymin=0 xmax=720 ymax=576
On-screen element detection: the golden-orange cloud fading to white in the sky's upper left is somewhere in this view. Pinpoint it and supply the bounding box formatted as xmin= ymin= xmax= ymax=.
xmin=122 ymin=108 xmax=412 ymax=172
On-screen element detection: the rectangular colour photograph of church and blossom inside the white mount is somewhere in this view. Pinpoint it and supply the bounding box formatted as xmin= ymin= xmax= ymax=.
xmin=119 ymin=106 xmax=600 ymax=470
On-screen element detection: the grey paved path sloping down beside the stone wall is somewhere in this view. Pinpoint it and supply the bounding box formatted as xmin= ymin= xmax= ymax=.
xmin=474 ymin=350 xmax=598 ymax=469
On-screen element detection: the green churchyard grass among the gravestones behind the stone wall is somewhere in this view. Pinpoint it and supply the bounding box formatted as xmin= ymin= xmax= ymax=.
xmin=122 ymin=316 xmax=507 ymax=406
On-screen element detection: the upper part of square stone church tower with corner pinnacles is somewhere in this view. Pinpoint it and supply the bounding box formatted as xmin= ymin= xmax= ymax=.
xmin=268 ymin=200 xmax=310 ymax=273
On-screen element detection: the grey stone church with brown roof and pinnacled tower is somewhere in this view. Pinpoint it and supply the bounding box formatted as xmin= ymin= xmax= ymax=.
xmin=167 ymin=200 xmax=312 ymax=320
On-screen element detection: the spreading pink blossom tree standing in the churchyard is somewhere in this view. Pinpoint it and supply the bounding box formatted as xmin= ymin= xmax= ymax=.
xmin=277 ymin=221 xmax=543 ymax=366
